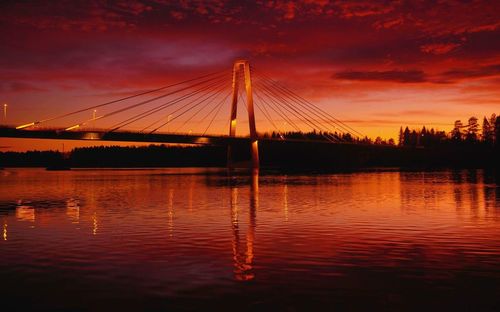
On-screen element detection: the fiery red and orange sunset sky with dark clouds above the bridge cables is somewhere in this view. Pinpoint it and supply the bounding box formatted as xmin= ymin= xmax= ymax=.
xmin=0 ymin=0 xmax=500 ymax=150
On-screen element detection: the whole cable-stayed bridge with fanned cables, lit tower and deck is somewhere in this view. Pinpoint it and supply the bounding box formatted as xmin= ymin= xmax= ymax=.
xmin=0 ymin=60 xmax=363 ymax=168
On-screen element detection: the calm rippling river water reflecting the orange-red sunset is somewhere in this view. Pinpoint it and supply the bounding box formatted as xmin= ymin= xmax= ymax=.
xmin=0 ymin=169 xmax=500 ymax=311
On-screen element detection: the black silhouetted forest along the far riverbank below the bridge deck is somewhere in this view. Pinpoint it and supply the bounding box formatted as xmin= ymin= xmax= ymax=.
xmin=0 ymin=114 xmax=500 ymax=170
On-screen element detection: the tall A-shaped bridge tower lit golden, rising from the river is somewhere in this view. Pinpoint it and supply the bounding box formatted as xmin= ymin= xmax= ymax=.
xmin=227 ymin=60 xmax=259 ymax=169
